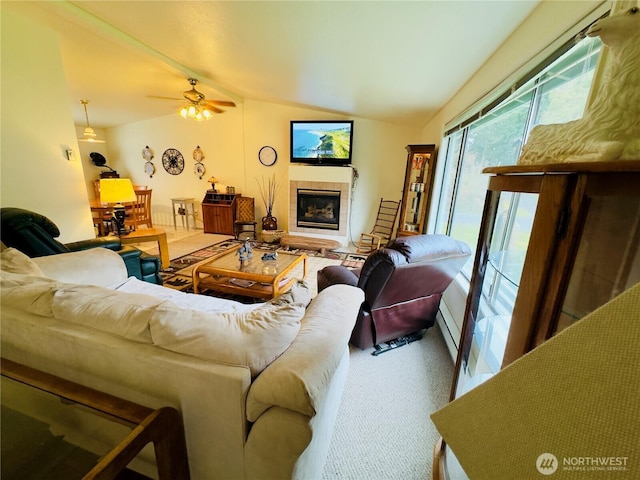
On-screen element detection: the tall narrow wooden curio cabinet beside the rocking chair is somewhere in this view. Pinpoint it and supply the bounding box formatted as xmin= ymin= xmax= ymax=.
xmin=398 ymin=145 xmax=436 ymax=237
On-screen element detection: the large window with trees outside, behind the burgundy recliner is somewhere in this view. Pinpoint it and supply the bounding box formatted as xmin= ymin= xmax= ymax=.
xmin=435 ymin=33 xmax=601 ymax=284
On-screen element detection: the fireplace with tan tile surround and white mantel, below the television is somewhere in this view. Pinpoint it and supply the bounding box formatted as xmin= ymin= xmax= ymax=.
xmin=289 ymin=165 xmax=352 ymax=245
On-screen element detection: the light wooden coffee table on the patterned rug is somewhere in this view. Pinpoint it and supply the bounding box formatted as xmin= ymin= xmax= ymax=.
xmin=193 ymin=248 xmax=307 ymax=299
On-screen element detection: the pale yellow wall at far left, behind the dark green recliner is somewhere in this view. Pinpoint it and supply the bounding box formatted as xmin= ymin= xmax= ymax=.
xmin=0 ymin=5 xmax=94 ymax=242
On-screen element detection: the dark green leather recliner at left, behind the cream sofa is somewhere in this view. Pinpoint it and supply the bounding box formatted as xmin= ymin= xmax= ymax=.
xmin=0 ymin=207 xmax=162 ymax=285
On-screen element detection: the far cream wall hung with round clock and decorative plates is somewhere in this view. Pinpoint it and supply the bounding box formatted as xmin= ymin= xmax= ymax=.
xmin=101 ymin=100 xmax=420 ymax=241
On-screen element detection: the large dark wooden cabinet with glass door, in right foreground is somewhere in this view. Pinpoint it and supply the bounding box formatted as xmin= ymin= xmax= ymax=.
xmin=434 ymin=161 xmax=640 ymax=478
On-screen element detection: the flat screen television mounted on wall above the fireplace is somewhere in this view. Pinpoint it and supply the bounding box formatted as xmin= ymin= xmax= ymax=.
xmin=291 ymin=120 xmax=353 ymax=166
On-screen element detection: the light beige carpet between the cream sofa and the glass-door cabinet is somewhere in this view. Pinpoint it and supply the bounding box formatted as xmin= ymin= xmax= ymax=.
xmin=323 ymin=326 xmax=453 ymax=480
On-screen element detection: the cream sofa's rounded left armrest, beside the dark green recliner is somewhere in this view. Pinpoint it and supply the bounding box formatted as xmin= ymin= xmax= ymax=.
xmin=32 ymin=248 xmax=128 ymax=287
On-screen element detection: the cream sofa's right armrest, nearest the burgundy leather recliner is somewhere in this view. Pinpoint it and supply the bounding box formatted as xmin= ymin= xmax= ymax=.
xmin=247 ymin=285 xmax=364 ymax=422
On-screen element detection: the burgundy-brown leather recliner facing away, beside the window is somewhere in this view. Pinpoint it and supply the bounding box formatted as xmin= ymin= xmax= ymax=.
xmin=318 ymin=235 xmax=471 ymax=349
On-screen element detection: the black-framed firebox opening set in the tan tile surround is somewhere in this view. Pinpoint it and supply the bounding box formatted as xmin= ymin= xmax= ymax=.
xmin=296 ymin=189 xmax=340 ymax=230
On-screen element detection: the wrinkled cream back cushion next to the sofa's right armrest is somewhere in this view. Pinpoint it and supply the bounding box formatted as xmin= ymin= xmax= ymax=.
xmin=150 ymin=282 xmax=310 ymax=376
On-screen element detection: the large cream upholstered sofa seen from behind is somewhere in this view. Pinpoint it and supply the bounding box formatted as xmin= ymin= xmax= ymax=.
xmin=1 ymin=248 xmax=363 ymax=480
